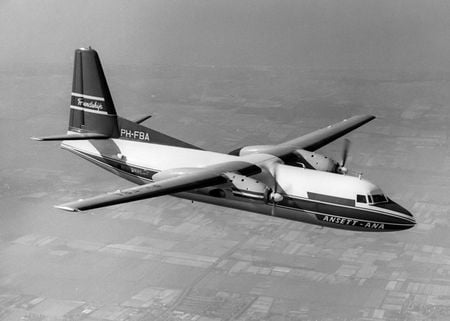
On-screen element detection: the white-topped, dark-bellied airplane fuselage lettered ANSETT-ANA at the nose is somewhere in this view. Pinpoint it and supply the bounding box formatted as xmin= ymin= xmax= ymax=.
xmin=61 ymin=139 xmax=415 ymax=231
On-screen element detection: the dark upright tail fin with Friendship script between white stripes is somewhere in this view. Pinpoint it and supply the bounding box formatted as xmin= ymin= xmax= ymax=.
xmin=69 ymin=47 xmax=119 ymax=137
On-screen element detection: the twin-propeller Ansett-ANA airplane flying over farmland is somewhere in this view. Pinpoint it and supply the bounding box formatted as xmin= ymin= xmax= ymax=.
xmin=32 ymin=47 xmax=416 ymax=232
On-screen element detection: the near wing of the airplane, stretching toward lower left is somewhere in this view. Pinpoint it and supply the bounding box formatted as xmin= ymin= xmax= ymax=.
xmin=55 ymin=161 xmax=260 ymax=212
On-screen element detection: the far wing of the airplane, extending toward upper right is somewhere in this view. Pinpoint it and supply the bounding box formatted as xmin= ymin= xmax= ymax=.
xmin=230 ymin=115 xmax=375 ymax=160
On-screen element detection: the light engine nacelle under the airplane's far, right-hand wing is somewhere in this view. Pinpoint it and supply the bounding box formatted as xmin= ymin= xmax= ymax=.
xmin=286 ymin=149 xmax=339 ymax=173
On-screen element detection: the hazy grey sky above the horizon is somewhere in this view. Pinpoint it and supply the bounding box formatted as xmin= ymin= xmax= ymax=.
xmin=0 ymin=0 xmax=450 ymax=70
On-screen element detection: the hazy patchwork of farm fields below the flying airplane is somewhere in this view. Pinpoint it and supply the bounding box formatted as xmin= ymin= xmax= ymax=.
xmin=0 ymin=0 xmax=450 ymax=321
